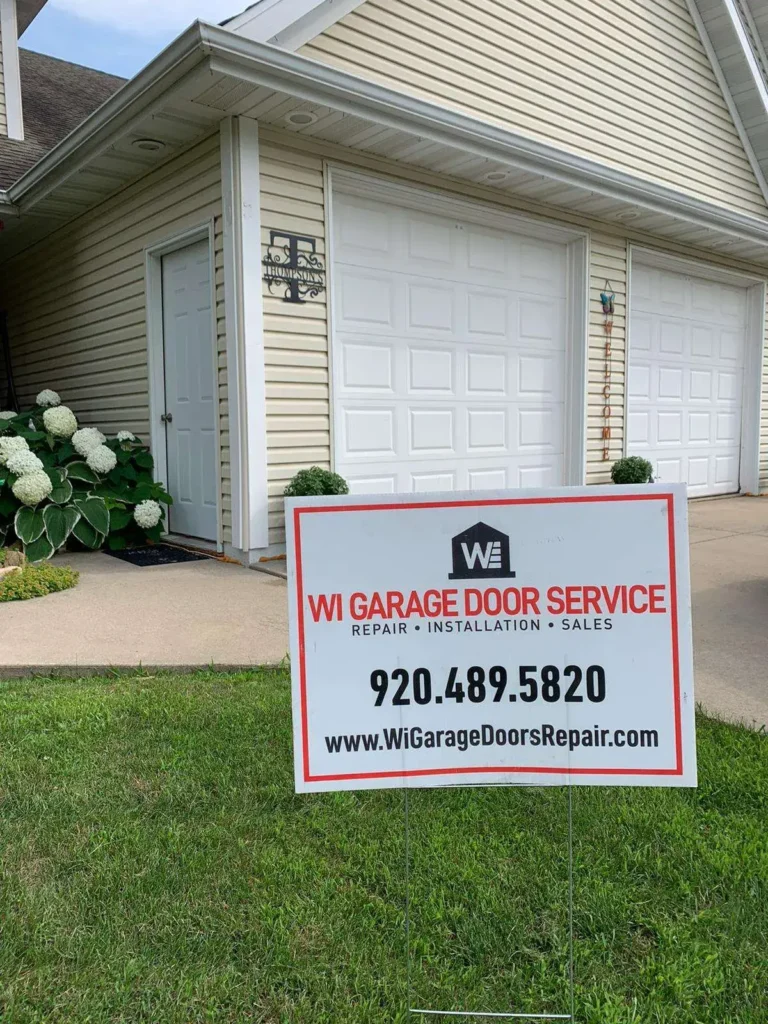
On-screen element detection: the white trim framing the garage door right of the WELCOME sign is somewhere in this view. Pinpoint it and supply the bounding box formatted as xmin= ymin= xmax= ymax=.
xmin=622 ymin=243 xmax=767 ymax=497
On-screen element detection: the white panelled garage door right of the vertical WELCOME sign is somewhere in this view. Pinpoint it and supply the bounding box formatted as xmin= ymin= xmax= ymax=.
xmin=627 ymin=265 xmax=746 ymax=497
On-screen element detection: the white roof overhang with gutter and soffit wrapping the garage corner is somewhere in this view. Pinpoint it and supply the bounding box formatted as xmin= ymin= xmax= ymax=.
xmin=0 ymin=24 xmax=768 ymax=266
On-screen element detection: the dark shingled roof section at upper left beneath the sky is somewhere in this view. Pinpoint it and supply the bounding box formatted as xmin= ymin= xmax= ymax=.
xmin=0 ymin=48 xmax=125 ymax=188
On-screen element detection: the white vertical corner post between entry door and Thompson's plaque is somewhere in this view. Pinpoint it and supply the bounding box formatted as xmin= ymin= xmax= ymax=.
xmin=221 ymin=117 xmax=269 ymax=552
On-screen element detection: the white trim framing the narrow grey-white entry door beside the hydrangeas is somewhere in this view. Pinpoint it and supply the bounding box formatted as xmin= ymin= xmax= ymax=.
xmin=144 ymin=220 xmax=223 ymax=551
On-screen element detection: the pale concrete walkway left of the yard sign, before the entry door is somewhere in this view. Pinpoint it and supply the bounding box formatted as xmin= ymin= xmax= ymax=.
xmin=0 ymin=552 xmax=288 ymax=678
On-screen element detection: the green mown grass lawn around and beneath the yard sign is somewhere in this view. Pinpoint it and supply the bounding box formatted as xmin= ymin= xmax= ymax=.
xmin=0 ymin=672 xmax=768 ymax=1024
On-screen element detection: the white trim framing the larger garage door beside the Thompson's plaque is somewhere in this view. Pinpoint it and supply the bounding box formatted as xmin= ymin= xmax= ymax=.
xmin=325 ymin=161 xmax=591 ymax=486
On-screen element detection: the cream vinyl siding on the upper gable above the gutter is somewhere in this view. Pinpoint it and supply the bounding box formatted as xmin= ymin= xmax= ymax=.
xmin=300 ymin=0 xmax=767 ymax=215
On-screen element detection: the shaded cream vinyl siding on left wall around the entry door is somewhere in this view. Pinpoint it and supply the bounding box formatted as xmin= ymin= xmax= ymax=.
xmin=0 ymin=134 xmax=231 ymax=540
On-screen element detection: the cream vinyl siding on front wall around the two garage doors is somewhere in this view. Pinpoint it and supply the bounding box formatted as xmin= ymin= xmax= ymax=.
xmin=260 ymin=129 xmax=768 ymax=544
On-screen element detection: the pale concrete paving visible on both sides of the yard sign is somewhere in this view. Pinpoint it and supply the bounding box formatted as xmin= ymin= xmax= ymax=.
xmin=0 ymin=498 xmax=768 ymax=726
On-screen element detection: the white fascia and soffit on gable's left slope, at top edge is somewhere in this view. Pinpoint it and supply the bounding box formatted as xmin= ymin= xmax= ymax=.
xmin=226 ymin=0 xmax=365 ymax=50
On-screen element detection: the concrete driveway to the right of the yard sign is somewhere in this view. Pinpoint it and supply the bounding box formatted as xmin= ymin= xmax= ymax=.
xmin=689 ymin=498 xmax=768 ymax=726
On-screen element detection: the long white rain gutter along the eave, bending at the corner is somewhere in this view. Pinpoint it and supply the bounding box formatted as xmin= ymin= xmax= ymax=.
xmin=9 ymin=23 xmax=768 ymax=249
